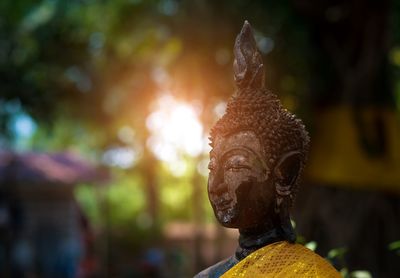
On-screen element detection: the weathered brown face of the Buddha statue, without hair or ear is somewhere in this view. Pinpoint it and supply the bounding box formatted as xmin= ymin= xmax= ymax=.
xmin=208 ymin=131 xmax=275 ymax=229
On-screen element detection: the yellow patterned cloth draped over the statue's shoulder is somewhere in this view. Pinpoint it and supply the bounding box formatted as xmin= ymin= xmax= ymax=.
xmin=221 ymin=241 xmax=341 ymax=278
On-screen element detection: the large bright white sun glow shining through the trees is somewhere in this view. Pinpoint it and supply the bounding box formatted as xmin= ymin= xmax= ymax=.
xmin=146 ymin=95 xmax=204 ymax=168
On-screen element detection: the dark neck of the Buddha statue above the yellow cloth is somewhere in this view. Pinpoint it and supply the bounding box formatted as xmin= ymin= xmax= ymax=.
xmin=235 ymin=214 xmax=296 ymax=261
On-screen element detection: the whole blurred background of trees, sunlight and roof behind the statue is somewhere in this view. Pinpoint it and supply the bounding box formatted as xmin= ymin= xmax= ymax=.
xmin=0 ymin=0 xmax=400 ymax=277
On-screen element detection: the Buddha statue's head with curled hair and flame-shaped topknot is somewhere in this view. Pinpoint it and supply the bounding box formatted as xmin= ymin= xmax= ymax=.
xmin=208 ymin=21 xmax=309 ymax=240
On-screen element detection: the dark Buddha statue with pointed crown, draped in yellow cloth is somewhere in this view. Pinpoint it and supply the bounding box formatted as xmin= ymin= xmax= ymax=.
xmin=195 ymin=21 xmax=340 ymax=278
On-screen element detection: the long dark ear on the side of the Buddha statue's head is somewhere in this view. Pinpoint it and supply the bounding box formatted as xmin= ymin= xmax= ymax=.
xmin=274 ymin=151 xmax=301 ymax=196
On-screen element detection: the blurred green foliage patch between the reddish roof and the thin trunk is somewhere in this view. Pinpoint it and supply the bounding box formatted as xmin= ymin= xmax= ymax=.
xmin=75 ymin=171 xmax=159 ymax=251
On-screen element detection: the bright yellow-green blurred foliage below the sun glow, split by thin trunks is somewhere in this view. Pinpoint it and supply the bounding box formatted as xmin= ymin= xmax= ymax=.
xmin=75 ymin=158 xmax=214 ymax=248
